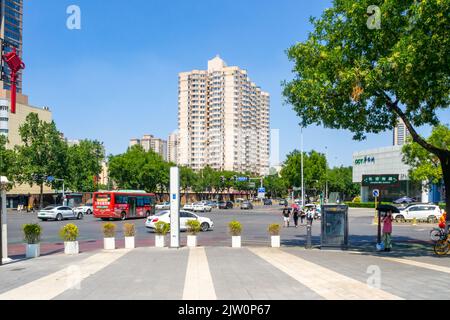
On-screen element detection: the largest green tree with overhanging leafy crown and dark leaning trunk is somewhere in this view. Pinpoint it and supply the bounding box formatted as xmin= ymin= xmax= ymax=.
xmin=284 ymin=0 xmax=450 ymax=221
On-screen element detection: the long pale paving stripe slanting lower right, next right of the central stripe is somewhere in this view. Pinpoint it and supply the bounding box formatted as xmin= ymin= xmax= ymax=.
xmin=249 ymin=248 xmax=403 ymax=300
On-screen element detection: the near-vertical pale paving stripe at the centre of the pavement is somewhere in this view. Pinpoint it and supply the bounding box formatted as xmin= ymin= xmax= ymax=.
xmin=183 ymin=248 xmax=217 ymax=300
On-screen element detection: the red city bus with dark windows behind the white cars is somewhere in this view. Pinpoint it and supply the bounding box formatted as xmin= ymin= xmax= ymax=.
xmin=93 ymin=190 xmax=156 ymax=220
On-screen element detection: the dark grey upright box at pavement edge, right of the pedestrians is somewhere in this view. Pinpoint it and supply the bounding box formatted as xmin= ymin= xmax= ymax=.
xmin=321 ymin=205 xmax=348 ymax=250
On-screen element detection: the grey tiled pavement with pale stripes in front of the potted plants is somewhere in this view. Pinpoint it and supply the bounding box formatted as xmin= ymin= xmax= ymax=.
xmin=0 ymin=247 xmax=450 ymax=300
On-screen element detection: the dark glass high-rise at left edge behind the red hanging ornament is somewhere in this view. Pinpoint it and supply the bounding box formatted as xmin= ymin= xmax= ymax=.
xmin=0 ymin=0 xmax=23 ymax=93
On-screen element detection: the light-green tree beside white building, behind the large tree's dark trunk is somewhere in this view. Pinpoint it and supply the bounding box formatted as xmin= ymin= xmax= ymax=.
xmin=403 ymin=125 xmax=450 ymax=183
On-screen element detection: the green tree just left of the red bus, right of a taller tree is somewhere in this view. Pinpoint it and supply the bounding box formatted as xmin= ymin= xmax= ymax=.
xmin=65 ymin=140 xmax=105 ymax=192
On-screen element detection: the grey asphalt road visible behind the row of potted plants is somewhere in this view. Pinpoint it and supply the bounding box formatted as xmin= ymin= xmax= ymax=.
xmin=2 ymin=206 xmax=432 ymax=255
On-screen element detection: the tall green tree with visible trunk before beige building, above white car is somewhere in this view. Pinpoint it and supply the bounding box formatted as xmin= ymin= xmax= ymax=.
xmin=13 ymin=113 xmax=68 ymax=208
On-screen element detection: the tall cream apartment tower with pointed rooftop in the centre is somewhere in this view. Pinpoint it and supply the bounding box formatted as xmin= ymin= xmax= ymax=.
xmin=178 ymin=56 xmax=270 ymax=175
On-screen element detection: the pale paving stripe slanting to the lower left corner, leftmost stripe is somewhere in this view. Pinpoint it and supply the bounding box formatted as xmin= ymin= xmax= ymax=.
xmin=0 ymin=250 xmax=129 ymax=300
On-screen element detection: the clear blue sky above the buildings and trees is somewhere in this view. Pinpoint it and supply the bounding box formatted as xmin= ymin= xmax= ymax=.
xmin=23 ymin=0 xmax=450 ymax=165
